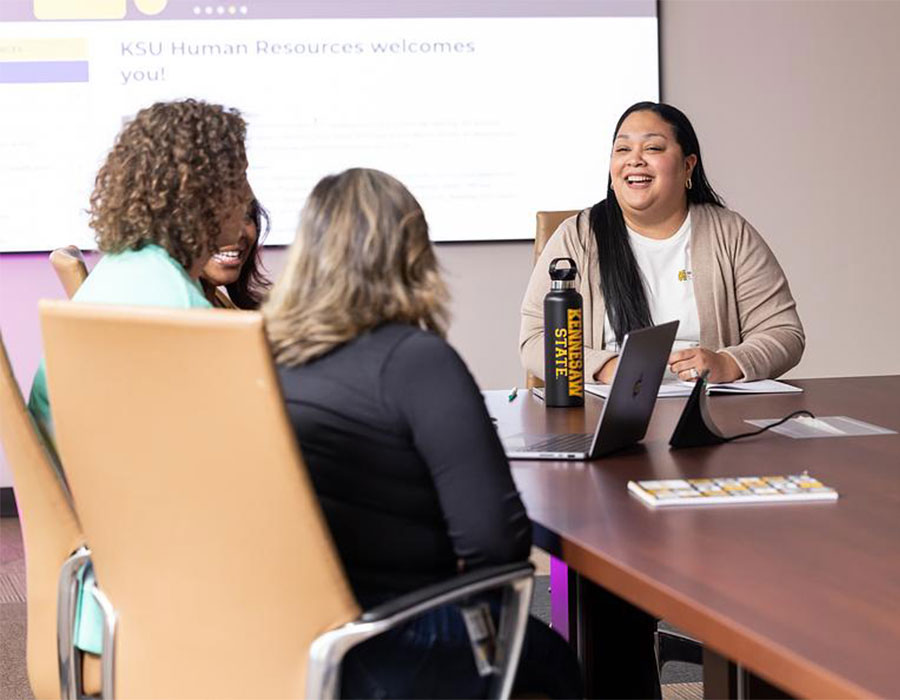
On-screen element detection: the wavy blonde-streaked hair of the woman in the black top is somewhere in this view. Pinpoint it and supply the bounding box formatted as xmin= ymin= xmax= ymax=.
xmin=262 ymin=168 xmax=448 ymax=366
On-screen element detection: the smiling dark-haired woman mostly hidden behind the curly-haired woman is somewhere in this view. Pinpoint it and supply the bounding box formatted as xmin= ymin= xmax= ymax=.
xmin=200 ymin=199 xmax=272 ymax=309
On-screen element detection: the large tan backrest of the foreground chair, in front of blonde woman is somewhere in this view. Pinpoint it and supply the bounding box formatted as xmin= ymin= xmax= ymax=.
xmin=40 ymin=301 xmax=359 ymax=699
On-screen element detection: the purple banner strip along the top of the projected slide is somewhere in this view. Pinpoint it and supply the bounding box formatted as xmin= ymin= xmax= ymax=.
xmin=0 ymin=0 xmax=656 ymax=22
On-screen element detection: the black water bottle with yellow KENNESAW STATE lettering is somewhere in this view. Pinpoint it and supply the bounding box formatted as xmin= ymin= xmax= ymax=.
xmin=544 ymin=258 xmax=584 ymax=406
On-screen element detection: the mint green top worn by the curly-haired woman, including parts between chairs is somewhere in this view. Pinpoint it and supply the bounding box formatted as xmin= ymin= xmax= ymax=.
xmin=28 ymin=244 xmax=212 ymax=654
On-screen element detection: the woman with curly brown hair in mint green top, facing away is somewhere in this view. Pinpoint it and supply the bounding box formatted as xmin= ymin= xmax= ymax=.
xmin=29 ymin=100 xmax=253 ymax=435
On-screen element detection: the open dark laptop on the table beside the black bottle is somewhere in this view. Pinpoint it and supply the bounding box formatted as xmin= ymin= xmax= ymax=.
xmin=502 ymin=321 xmax=678 ymax=459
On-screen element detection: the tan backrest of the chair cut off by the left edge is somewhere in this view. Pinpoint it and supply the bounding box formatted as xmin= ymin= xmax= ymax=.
xmin=0 ymin=337 xmax=84 ymax=698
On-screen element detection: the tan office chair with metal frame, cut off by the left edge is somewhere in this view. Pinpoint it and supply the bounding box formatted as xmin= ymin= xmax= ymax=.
xmin=0 ymin=337 xmax=100 ymax=698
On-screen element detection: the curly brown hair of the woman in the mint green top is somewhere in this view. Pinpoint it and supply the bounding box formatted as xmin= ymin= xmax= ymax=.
xmin=90 ymin=100 xmax=249 ymax=270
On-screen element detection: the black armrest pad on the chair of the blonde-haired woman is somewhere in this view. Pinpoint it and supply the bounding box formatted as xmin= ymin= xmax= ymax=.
xmin=357 ymin=561 xmax=534 ymax=622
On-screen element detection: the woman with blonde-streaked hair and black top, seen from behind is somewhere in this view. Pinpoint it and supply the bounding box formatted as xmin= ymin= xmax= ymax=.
xmin=263 ymin=169 xmax=580 ymax=697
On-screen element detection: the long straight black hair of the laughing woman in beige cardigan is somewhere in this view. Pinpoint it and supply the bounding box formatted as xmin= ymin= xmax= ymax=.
xmin=590 ymin=102 xmax=725 ymax=343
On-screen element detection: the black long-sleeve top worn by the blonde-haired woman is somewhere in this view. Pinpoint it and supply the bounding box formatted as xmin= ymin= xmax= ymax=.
xmin=279 ymin=323 xmax=531 ymax=607
